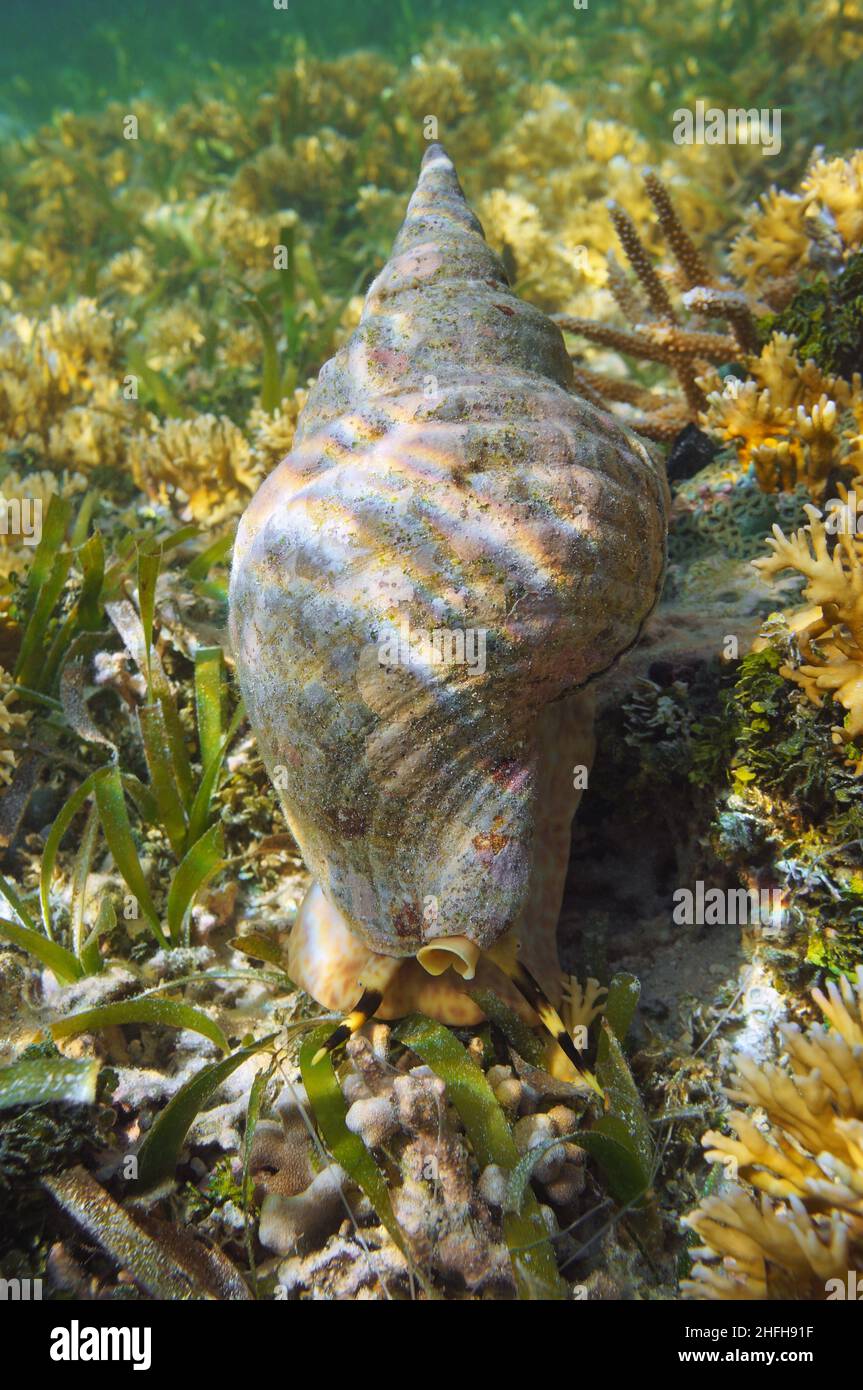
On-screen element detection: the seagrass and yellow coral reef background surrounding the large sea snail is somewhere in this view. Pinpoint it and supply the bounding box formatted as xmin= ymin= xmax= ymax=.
xmin=0 ymin=0 xmax=863 ymax=1300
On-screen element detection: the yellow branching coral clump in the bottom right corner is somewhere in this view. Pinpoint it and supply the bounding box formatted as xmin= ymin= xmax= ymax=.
xmin=681 ymin=966 xmax=863 ymax=1300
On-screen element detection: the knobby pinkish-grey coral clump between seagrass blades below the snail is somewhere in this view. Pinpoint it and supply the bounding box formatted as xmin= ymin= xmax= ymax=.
xmin=265 ymin=1023 xmax=586 ymax=1298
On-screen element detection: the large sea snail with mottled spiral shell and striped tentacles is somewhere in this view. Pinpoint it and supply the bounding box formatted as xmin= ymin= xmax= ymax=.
xmin=229 ymin=145 xmax=667 ymax=1067
